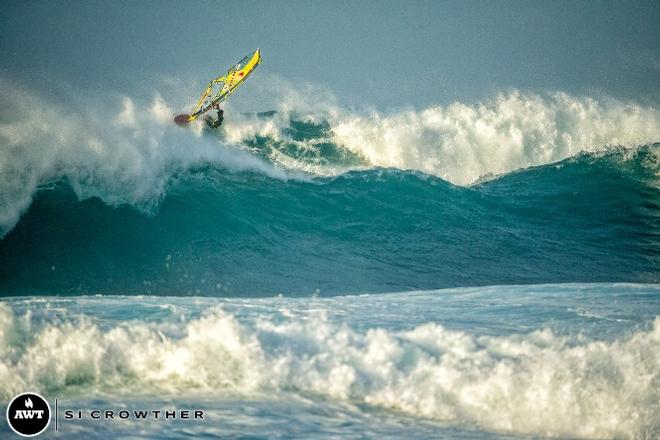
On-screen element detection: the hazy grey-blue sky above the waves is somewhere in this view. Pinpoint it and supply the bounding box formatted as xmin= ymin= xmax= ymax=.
xmin=0 ymin=0 xmax=660 ymax=110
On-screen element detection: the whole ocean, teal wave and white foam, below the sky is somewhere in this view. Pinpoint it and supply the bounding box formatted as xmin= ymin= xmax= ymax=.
xmin=0 ymin=81 xmax=660 ymax=439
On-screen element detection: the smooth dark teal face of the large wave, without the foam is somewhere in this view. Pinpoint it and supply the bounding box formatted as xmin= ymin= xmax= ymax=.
xmin=0 ymin=146 xmax=660 ymax=296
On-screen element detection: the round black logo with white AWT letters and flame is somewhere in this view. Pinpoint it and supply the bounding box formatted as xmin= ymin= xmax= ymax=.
xmin=7 ymin=393 xmax=50 ymax=437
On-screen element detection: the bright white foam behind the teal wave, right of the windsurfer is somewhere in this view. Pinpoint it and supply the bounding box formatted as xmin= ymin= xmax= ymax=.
xmin=332 ymin=91 xmax=660 ymax=185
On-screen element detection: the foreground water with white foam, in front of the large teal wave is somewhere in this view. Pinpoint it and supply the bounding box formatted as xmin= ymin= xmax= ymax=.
xmin=0 ymin=285 xmax=660 ymax=439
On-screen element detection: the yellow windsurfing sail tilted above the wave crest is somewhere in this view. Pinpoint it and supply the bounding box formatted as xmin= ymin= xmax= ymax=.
xmin=174 ymin=49 xmax=261 ymax=124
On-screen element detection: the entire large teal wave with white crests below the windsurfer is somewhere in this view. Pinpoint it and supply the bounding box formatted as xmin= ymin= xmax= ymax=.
xmin=0 ymin=81 xmax=660 ymax=296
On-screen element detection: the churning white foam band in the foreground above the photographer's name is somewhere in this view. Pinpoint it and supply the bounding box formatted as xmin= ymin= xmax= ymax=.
xmin=0 ymin=304 xmax=660 ymax=438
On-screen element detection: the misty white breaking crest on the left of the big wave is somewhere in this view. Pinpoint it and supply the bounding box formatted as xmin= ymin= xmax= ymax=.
xmin=0 ymin=78 xmax=287 ymax=236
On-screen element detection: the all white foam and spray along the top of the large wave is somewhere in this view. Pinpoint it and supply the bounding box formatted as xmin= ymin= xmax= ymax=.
xmin=0 ymin=80 xmax=660 ymax=232
